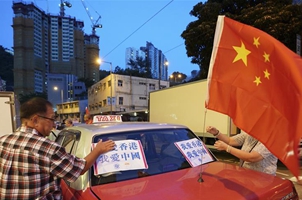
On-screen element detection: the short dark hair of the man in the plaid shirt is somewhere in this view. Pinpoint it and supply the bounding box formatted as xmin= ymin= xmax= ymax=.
xmin=20 ymin=97 xmax=52 ymax=120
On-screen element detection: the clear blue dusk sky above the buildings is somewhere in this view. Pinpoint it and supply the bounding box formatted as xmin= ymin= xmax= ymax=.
xmin=0 ymin=0 xmax=200 ymax=76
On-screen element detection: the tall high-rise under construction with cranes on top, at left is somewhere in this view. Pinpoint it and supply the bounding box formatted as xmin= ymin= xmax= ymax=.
xmin=12 ymin=2 xmax=99 ymax=95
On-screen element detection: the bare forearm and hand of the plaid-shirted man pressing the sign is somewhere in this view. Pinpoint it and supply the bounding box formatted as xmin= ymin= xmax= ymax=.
xmin=81 ymin=140 xmax=115 ymax=175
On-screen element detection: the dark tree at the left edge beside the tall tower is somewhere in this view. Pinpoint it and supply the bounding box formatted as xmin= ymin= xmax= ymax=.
xmin=0 ymin=45 xmax=14 ymax=91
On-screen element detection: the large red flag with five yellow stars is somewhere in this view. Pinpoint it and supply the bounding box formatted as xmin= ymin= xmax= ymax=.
xmin=206 ymin=16 xmax=302 ymax=177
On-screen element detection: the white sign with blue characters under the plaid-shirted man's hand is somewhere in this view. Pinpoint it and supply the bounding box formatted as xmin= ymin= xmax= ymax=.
xmin=92 ymin=140 xmax=148 ymax=175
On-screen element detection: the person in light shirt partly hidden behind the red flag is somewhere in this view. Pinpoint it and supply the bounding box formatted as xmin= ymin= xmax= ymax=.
xmin=206 ymin=126 xmax=278 ymax=175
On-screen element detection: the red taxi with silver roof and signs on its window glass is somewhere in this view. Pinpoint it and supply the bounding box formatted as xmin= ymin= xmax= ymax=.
xmin=56 ymin=119 xmax=299 ymax=200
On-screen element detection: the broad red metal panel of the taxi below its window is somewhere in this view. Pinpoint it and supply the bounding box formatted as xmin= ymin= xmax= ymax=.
xmin=91 ymin=162 xmax=293 ymax=200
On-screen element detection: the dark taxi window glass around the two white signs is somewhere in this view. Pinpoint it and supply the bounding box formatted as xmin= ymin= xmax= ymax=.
xmin=91 ymin=129 xmax=215 ymax=186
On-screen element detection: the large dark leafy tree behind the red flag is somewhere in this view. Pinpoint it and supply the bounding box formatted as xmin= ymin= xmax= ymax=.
xmin=181 ymin=0 xmax=302 ymax=79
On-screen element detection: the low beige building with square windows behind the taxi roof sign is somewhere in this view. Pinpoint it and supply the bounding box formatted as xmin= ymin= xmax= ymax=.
xmin=88 ymin=74 xmax=169 ymax=115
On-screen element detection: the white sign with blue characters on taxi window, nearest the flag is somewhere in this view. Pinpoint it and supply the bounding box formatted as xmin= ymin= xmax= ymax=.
xmin=174 ymin=138 xmax=213 ymax=167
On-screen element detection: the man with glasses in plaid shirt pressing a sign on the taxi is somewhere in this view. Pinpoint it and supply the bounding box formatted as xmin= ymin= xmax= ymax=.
xmin=0 ymin=97 xmax=115 ymax=199
